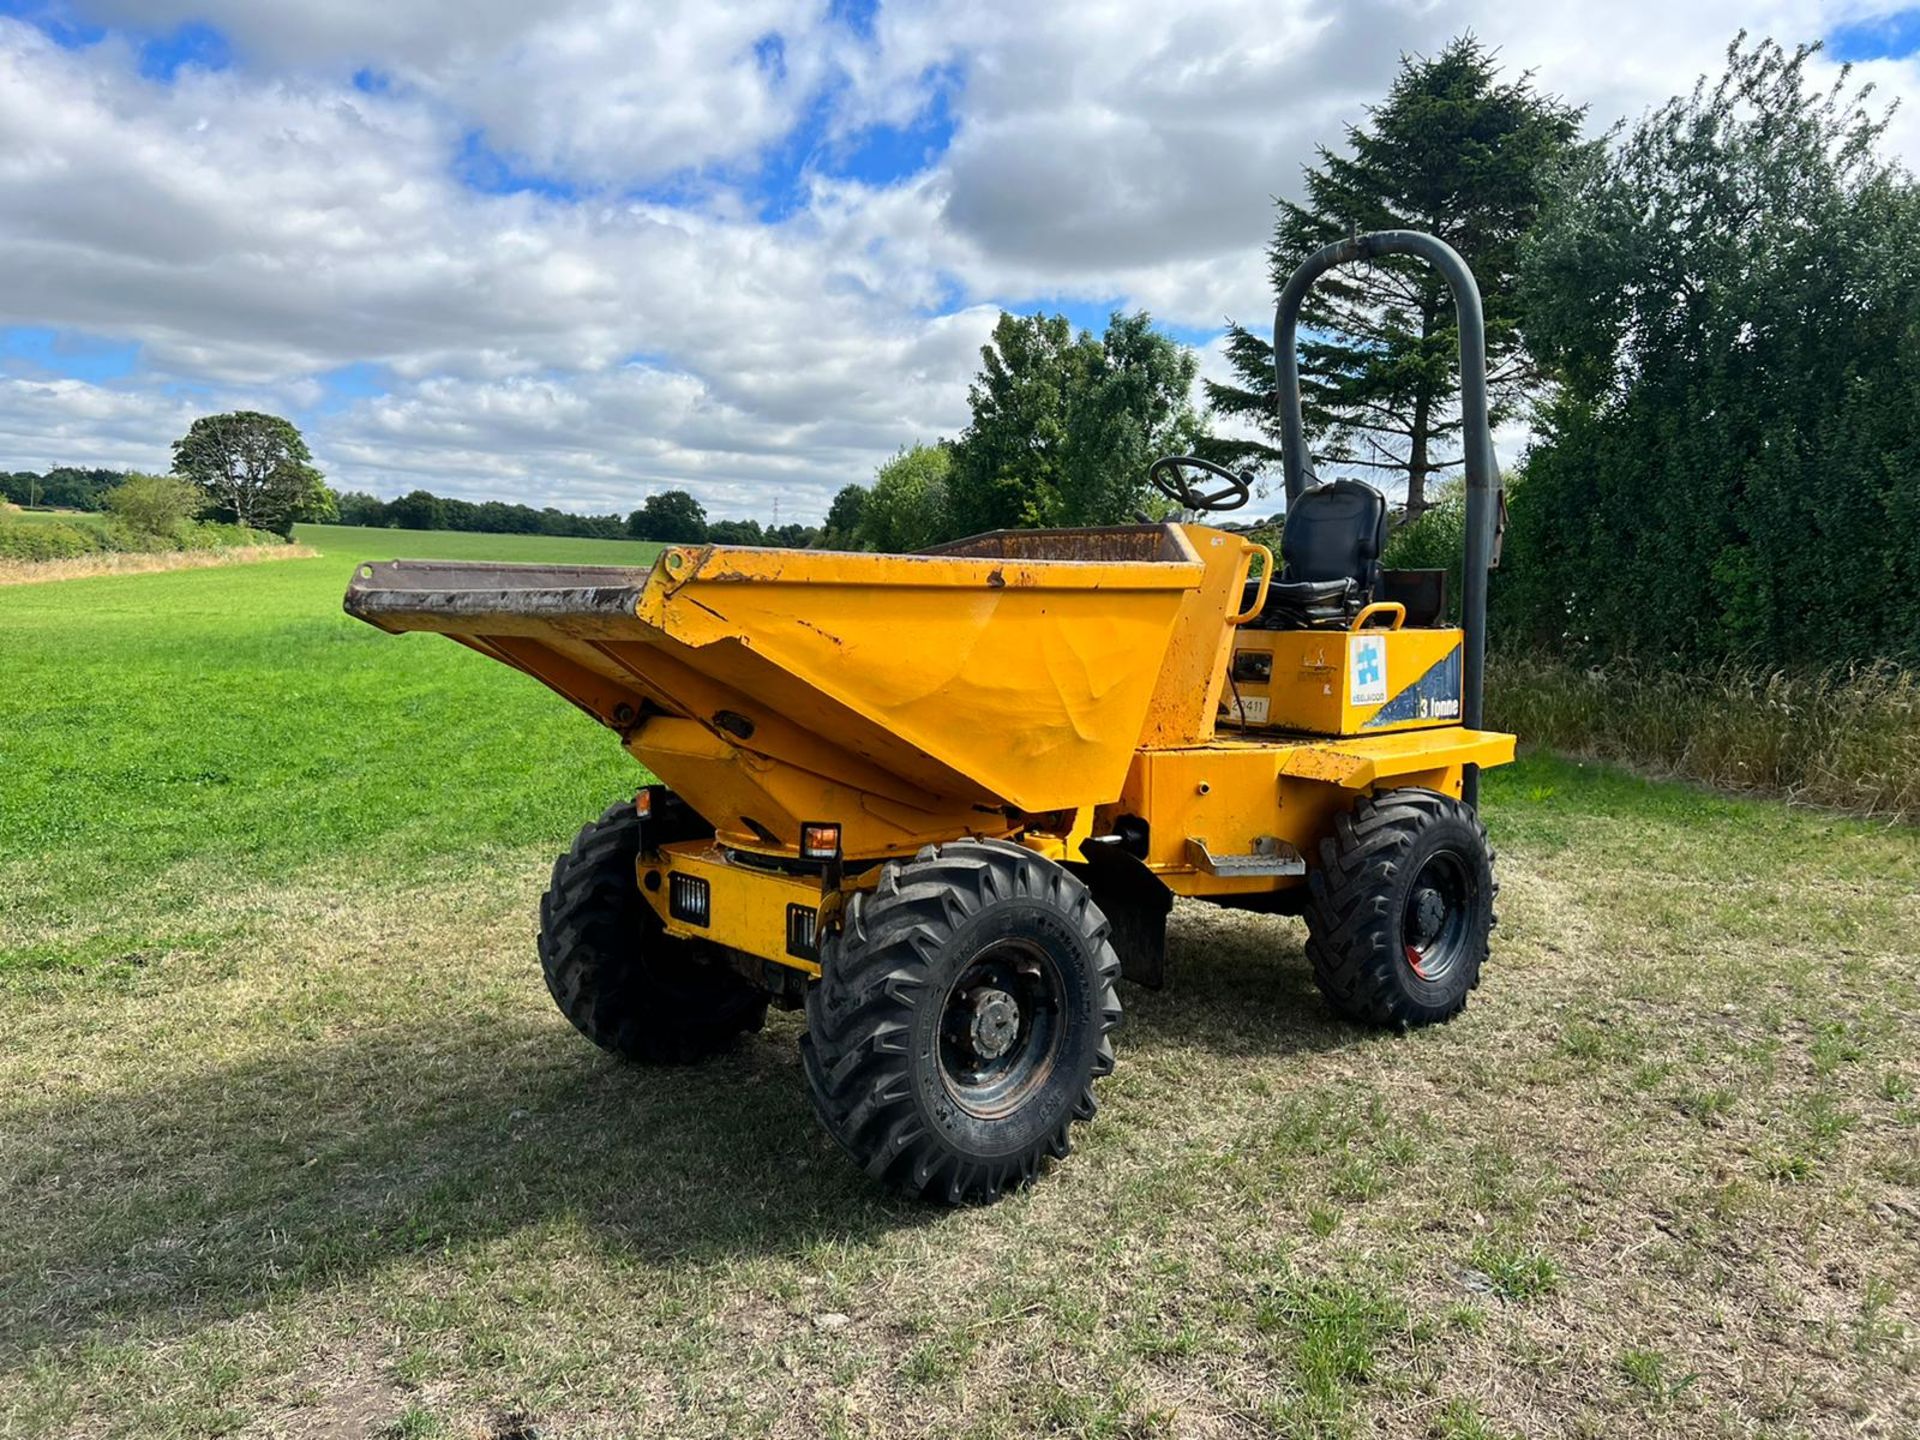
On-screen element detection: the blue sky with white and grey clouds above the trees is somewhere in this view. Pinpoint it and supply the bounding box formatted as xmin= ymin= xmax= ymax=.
xmin=0 ymin=0 xmax=1920 ymax=515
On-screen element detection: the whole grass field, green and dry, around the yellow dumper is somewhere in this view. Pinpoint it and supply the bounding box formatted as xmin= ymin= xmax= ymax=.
xmin=0 ymin=528 xmax=1920 ymax=1440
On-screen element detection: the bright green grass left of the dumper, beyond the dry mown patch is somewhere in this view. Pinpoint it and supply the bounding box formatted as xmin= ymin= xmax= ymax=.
xmin=0 ymin=526 xmax=655 ymax=970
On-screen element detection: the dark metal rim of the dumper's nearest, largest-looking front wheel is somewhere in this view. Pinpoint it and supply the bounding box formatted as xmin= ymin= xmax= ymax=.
xmin=939 ymin=941 xmax=1064 ymax=1119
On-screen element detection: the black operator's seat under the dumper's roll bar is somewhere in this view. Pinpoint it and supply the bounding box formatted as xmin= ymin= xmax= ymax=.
xmin=1250 ymin=480 xmax=1386 ymax=630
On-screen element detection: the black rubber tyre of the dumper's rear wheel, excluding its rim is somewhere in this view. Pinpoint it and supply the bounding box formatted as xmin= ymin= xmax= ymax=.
xmin=1306 ymin=789 xmax=1500 ymax=1029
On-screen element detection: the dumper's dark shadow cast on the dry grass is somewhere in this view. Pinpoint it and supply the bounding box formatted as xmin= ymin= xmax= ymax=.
xmin=0 ymin=912 xmax=1367 ymax=1363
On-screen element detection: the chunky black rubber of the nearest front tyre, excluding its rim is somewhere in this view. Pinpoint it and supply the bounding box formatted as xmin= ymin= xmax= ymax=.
xmin=801 ymin=841 xmax=1121 ymax=1204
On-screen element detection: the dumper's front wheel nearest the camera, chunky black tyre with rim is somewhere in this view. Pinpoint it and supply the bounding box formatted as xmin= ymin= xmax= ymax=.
xmin=801 ymin=841 xmax=1119 ymax=1204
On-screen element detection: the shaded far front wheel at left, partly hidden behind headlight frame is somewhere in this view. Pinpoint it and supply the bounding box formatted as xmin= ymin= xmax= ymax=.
xmin=540 ymin=791 xmax=766 ymax=1064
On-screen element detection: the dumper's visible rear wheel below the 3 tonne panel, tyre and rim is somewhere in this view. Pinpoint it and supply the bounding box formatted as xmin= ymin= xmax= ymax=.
xmin=1306 ymin=789 xmax=1500 ymax=1029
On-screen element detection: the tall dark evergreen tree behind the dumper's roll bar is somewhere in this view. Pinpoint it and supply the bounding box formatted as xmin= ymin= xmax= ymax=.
xmin=1208 ymin=35 xmax=1582 ymax=520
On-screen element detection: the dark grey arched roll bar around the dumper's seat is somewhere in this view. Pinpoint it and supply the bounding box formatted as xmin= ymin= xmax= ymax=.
xmin=1273 ymin=230 xmax=1500 ymax=808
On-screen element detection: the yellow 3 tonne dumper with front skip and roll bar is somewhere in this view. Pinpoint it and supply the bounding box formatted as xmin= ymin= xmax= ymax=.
xmin=346 ymin=232 xmax=1513 ymax=1202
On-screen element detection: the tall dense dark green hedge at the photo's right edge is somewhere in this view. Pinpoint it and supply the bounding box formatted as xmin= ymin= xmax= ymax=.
xmin=1496 ymin=42 xmax=1920 ymax=674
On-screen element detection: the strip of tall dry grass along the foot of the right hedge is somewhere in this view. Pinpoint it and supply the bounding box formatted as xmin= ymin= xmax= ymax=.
xmin=1488 ymin=651 xmax=1920 ymax=822
